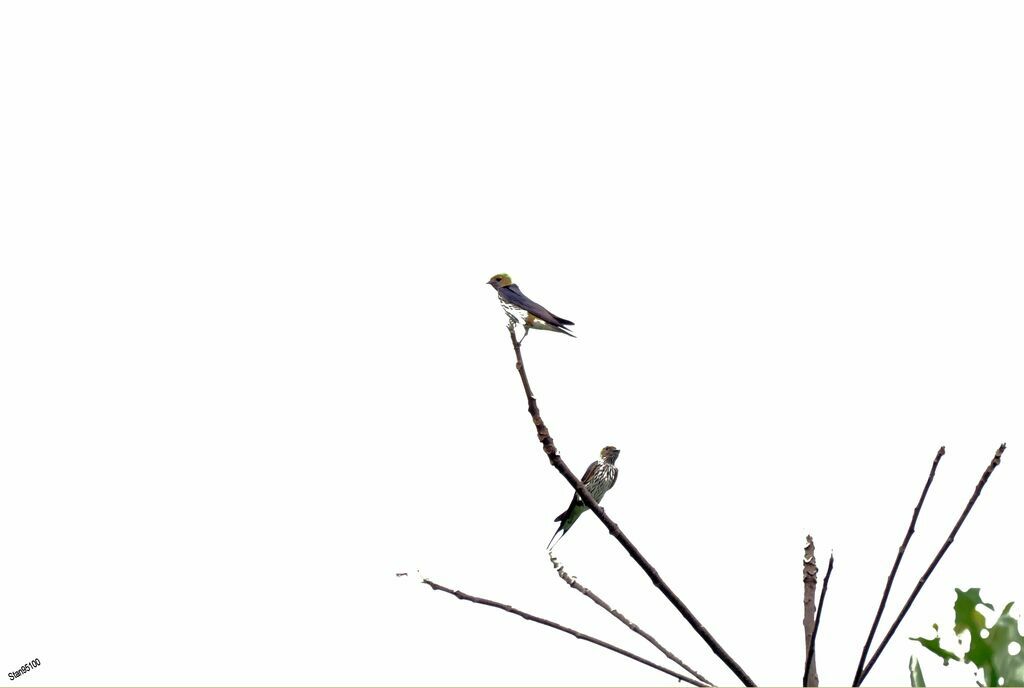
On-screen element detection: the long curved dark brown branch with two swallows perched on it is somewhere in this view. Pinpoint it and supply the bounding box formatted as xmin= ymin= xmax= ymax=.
xmin=509 ymin=324 xmax=756 ymax=686
